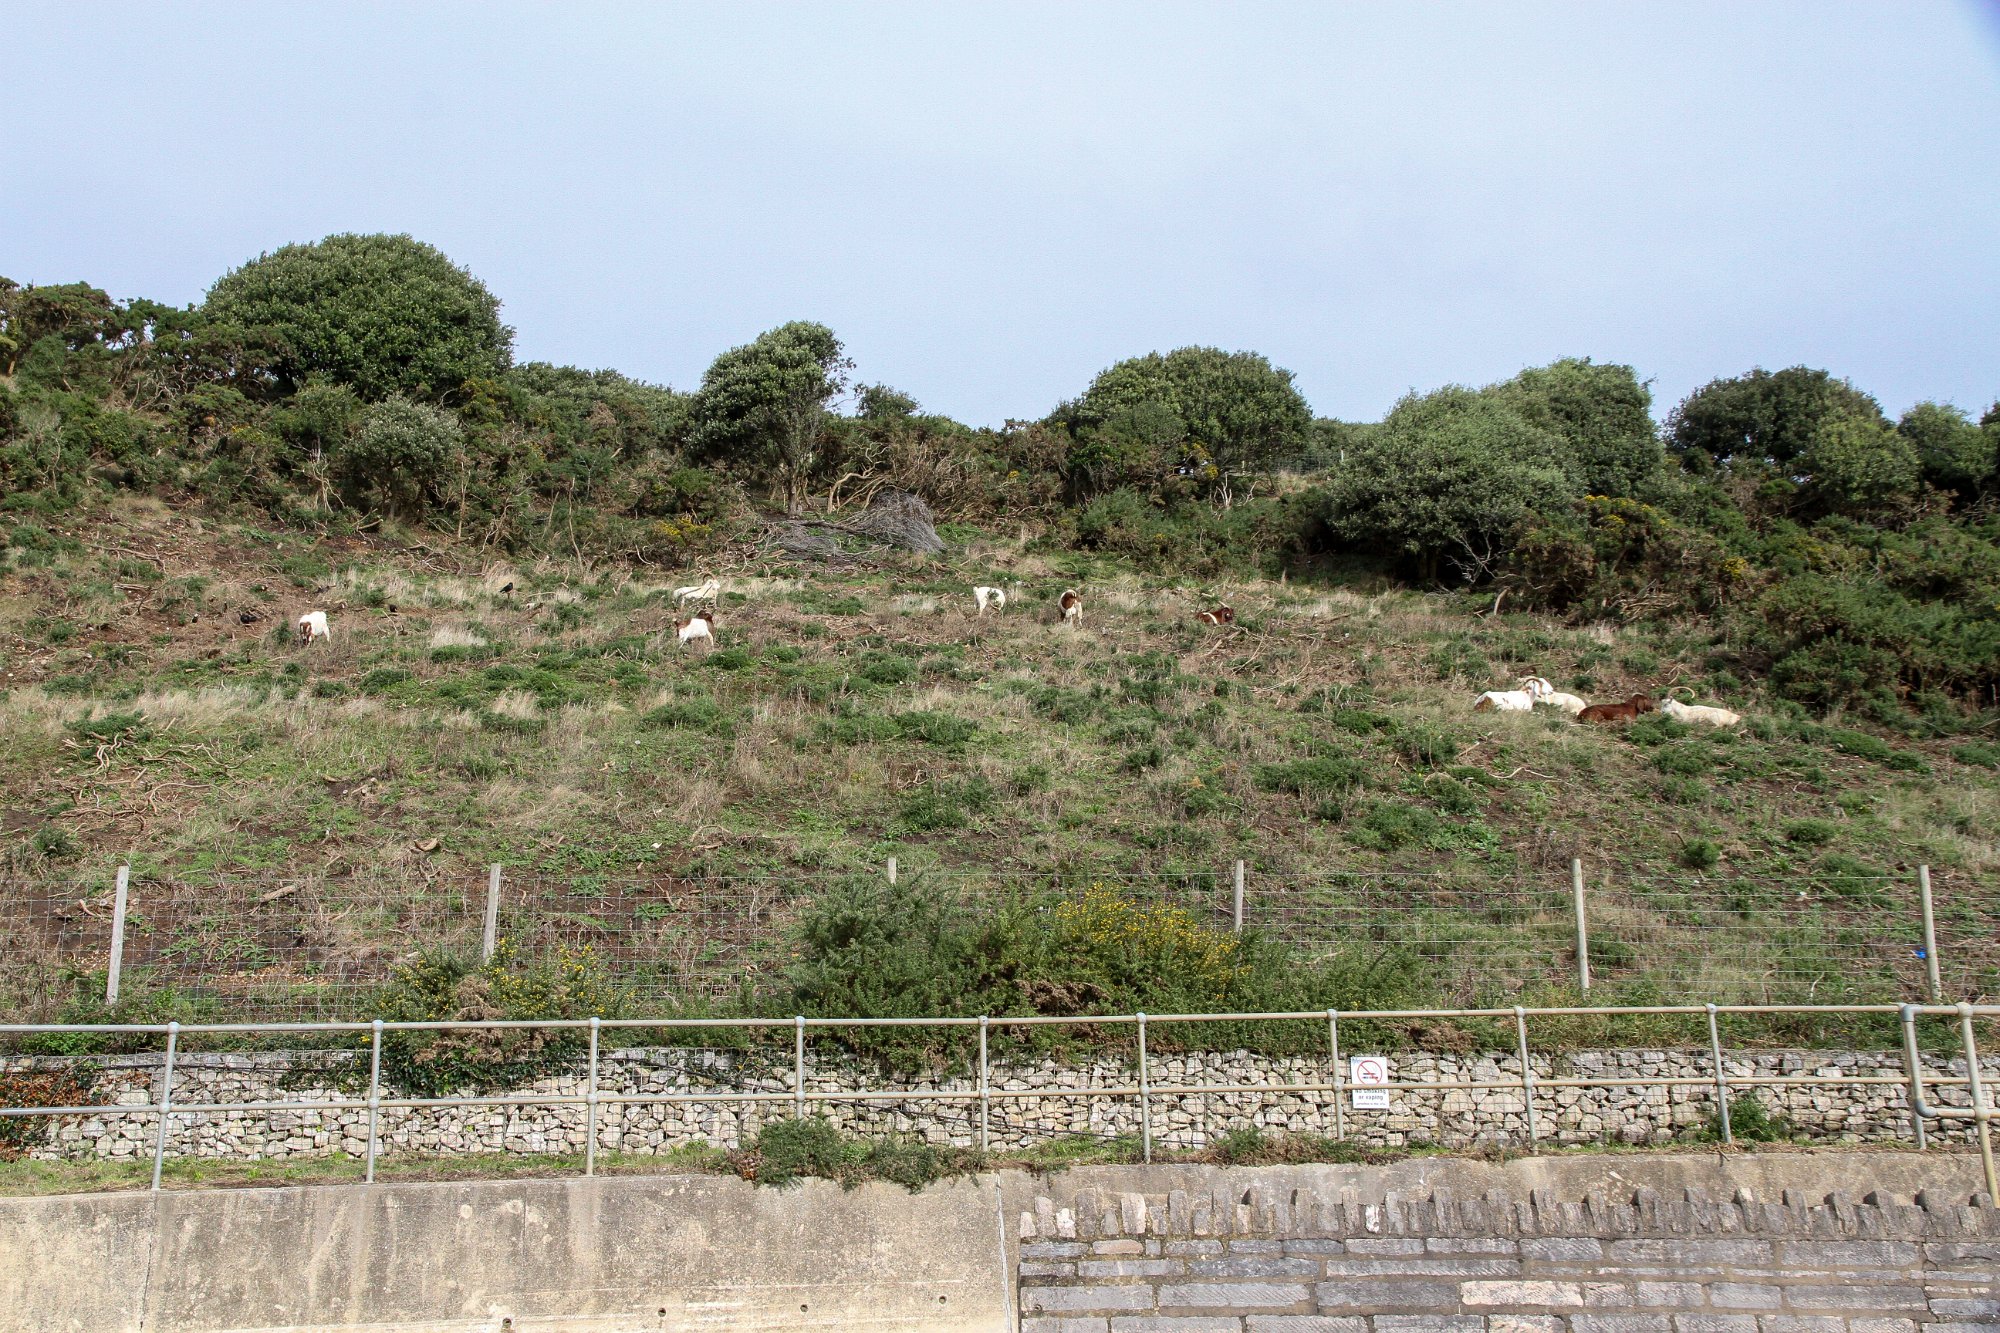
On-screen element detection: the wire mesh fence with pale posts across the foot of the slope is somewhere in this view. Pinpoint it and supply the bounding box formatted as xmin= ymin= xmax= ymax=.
xmin=0 ymin=852 xmax=2000 ymax=1021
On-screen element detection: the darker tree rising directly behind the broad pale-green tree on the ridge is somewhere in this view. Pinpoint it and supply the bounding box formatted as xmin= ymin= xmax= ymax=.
xmin=1488 ymin=356 xmax=1662 ymax=496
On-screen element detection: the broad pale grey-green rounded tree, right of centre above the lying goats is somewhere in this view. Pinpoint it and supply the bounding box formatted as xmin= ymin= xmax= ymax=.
xmin=1326 ymin=384 xmax=1580 ymax=578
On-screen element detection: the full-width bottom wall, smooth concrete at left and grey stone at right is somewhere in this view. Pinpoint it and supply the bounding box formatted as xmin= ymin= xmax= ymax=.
xmin=0 ymin=1153 xmax=2000 ymax=1333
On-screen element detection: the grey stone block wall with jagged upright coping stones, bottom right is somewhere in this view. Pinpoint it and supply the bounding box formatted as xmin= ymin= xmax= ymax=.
xmin=1018 ymin=1189 xmax=2000 ymax=1333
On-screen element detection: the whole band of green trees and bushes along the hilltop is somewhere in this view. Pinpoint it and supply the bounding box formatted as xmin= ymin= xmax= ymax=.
xmin=0 ymin=236 xmax=2000 ymax=727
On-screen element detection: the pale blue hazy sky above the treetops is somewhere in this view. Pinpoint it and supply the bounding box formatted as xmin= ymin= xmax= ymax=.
xmin=0 ymin=0 xmax=2000 ymax=424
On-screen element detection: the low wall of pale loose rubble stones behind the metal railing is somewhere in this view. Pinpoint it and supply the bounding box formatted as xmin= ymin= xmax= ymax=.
xmin=0 ymin=1047 xmax=2000 ymax=1159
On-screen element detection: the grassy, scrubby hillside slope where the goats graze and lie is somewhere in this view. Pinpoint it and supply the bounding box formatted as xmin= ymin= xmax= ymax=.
xmin=0 ymin=496 xmax=2000 ymax=1013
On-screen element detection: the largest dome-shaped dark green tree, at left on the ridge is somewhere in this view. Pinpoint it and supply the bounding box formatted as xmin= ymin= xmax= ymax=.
xmin=202 ymin=234 xmax=514 ymax=400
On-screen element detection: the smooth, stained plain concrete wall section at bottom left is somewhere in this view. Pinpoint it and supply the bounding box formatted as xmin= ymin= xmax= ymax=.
xmin=0 ymin=1177 xmax=1012 ymax=1333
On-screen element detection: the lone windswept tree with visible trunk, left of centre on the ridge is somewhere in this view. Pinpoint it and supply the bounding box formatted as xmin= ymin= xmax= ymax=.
xmin=688 ymin=320 xmax=854 ymax=512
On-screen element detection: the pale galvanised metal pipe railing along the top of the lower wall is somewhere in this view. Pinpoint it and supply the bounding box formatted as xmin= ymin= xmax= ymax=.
xmin=0 ymin=1003 xmax=2000 ymax=1197
